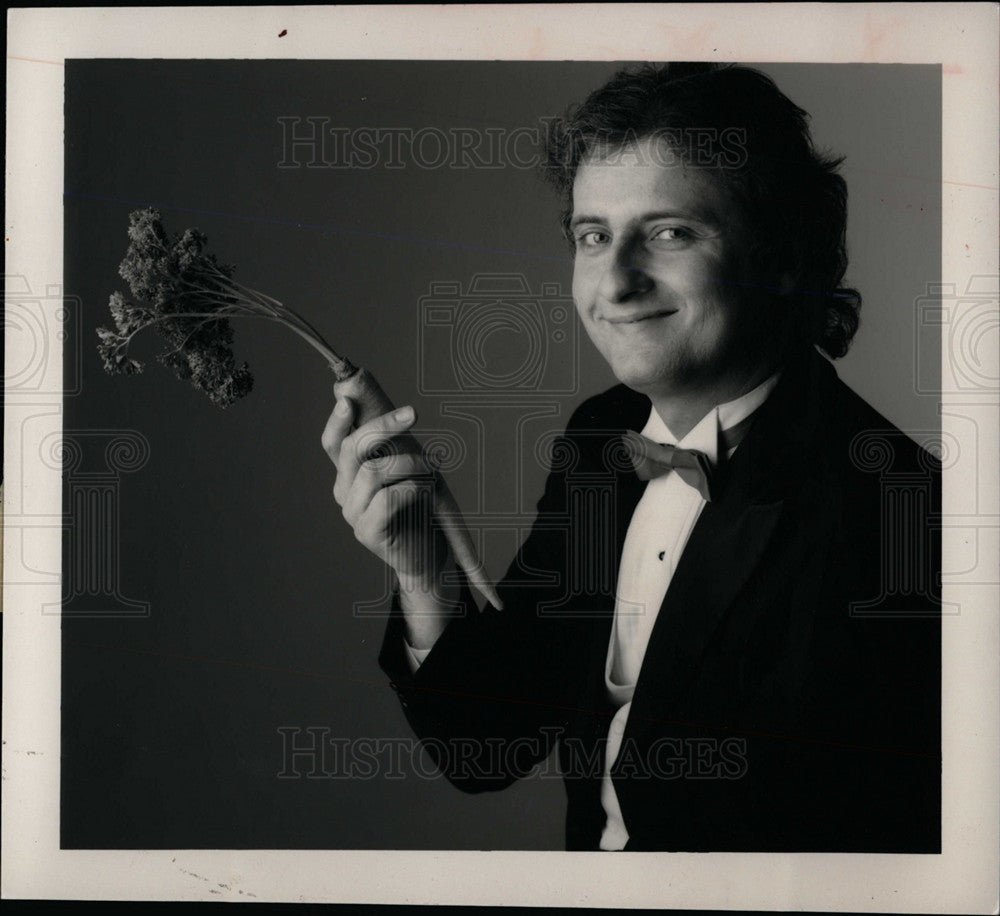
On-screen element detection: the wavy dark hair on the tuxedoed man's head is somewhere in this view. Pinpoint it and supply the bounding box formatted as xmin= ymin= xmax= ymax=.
xmin=544 ymin=63 xmax=861 ymax=358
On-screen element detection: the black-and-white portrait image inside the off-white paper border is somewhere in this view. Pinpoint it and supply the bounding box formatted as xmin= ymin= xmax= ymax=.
xmin=58 ymin=58 xmax=955 ymax=854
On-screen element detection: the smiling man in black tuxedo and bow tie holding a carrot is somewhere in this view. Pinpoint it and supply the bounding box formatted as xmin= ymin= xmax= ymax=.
xmin=324 ymin=64 xmax=941 ymax=852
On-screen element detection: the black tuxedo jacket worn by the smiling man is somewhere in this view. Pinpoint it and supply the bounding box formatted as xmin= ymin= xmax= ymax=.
xmin=379 ymin=351 xmax=941 ymax=853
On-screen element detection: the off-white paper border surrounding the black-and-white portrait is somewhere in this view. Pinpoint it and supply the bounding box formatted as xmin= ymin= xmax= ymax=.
xmin=2 ymin=3 xmax=1000 ymax=913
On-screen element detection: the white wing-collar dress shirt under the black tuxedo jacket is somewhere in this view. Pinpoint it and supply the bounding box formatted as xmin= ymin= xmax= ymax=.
xmin=404 ymin=373 xmax=780 ymax=850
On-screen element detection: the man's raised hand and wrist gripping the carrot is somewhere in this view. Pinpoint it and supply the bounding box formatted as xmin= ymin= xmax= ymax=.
xmin=321 ymin=395 xmax=448 ymax=648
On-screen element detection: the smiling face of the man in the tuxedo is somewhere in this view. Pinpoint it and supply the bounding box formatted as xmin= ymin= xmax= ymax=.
xmin=571 ymin=138 xmax=761 ymax=400
